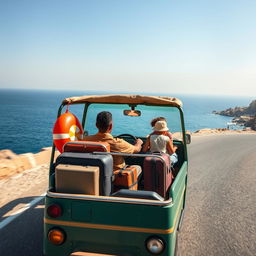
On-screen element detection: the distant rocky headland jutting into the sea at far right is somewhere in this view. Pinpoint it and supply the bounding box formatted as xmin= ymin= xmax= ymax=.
xmin=213 ymin=100 xmax=256 ymax=130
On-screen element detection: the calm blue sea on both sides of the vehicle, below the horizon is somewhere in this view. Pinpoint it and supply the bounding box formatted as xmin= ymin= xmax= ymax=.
xmin=0 ymin=89 xmax=255 ymax=154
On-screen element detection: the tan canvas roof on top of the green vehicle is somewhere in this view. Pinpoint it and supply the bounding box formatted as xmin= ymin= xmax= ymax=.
xmin=62 ymin=94 xmax=182 ymax=107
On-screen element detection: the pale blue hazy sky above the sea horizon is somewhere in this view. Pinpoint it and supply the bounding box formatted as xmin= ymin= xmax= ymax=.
xmin=0 ymin=0 xmax=256 ymax=96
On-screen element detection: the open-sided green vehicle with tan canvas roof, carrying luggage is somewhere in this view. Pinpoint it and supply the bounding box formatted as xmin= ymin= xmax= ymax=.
xmin=44 ymin=95 xmax=190 ymax=256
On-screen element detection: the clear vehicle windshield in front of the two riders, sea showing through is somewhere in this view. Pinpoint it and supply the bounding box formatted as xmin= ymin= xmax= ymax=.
xmin=85 ymin=104 xmax=182 ymax=137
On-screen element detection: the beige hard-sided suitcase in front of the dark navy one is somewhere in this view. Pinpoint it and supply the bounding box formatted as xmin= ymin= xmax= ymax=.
xmin=55 ymin=164 xmax=100 ymax=196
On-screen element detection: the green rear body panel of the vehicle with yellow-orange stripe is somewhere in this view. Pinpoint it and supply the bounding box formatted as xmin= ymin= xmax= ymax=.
xmin=45 ymin=197 xmax=176 ymax=256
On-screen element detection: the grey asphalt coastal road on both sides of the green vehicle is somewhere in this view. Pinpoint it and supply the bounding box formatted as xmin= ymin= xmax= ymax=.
xmin=0 ymin=134 xmax=256 ymax=256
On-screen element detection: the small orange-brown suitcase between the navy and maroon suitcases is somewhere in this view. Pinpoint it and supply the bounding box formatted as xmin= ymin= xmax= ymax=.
xmin=114 ymin=166 xmax=140 ymax=191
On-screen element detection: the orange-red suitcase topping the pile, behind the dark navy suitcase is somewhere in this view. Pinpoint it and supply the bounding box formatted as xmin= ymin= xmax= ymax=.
xmin=63 ymin=140 xmax=110 ymax=153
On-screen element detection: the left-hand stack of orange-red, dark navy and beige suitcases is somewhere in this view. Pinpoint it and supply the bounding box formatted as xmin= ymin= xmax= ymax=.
xmin=55 ymin=142 xmax=113 ymax=196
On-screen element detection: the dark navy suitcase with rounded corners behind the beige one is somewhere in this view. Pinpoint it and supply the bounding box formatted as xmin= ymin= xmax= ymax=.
xmin=56 ymin=152 xmax=113 ymax=196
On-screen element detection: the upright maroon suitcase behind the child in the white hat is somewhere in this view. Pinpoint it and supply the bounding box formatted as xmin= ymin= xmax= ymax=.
xmin=143 ymin=153 xmax=173 ymax=198
